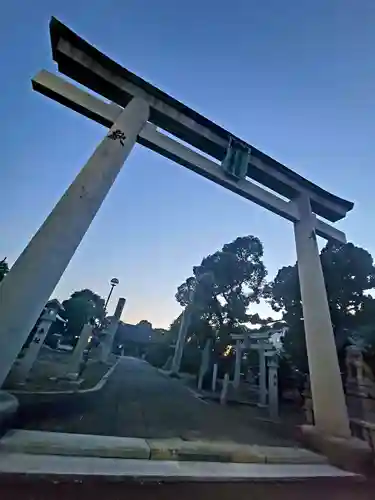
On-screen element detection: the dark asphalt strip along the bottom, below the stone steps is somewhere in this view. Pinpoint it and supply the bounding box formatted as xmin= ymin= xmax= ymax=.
xmin=0 ymin=476 xmax=374 ymax=500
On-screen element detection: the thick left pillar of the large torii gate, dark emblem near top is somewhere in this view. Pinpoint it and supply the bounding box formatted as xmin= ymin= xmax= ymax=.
xmin=0 ymin=98 xmax=149 ymax=387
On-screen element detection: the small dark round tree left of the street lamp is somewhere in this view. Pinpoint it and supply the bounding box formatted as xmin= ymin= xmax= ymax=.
xmin=60 ymin=289 xmax=105 ymax=343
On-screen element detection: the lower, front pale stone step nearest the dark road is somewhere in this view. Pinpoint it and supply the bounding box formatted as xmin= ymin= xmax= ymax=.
xmin=0 ymin=452 xmax=363 ymax=482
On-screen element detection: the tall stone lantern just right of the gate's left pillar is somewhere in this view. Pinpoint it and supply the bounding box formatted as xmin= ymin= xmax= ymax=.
xmin=15 ymin=307 xmax=58 ymax=382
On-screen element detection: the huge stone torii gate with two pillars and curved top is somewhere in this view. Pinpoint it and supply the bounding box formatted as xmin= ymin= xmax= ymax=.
xmin=0 ymin=18 xmax=353 ymax=438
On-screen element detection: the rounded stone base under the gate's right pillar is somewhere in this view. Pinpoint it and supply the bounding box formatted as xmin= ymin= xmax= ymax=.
xmin=299 ymin=425 xmax=374 ymax=475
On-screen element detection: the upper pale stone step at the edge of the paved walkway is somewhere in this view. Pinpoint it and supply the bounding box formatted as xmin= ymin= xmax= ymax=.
xmin=0 ymin=430 xmax=327 ymax=465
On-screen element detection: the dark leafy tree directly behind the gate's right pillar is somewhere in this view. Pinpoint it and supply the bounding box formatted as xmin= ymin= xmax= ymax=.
xmin=265 ymin=243 xmax=375 ymax=373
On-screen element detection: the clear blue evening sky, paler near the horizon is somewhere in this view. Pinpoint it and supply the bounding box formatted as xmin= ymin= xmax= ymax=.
xmin=0 ymin=0 xmax=375 ymax=326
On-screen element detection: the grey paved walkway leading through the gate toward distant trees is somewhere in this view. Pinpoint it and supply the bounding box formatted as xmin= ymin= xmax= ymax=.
xmin=16 ymin=357 xmax=292 ymax=446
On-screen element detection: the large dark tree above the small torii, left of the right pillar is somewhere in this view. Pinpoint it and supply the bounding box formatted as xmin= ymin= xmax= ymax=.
xmin=176 ymin=236 xmax=267 ymax=354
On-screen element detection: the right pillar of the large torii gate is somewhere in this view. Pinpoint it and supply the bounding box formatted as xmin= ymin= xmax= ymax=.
xmin=294 ymin=195 xmax=351 ymax=438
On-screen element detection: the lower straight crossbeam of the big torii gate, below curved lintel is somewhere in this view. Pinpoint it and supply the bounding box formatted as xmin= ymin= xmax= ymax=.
xmin=32 ymin=70 xmax=346 ymax=243
